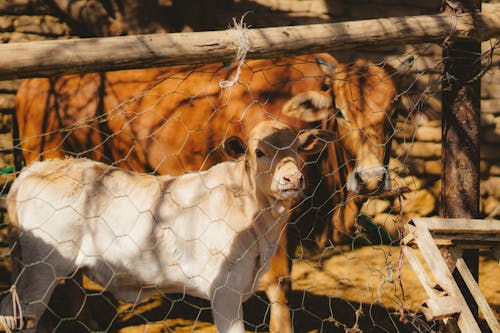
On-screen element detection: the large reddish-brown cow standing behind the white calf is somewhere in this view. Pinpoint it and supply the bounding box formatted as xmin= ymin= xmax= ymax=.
xmin=16 ymin=54 xmax=396 ymax=332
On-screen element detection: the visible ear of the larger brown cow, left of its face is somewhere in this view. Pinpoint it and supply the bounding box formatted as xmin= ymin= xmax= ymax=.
xmin=282 ymin=90 xmax=333 ymax=122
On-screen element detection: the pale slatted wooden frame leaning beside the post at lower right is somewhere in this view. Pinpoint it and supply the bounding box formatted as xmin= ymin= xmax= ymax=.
xmin=403 ymin=218 xmax=500 ymax=333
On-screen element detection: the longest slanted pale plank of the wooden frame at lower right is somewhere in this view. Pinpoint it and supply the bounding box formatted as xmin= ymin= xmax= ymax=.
xmin=415 ymin=224 xmax=481 ymax=333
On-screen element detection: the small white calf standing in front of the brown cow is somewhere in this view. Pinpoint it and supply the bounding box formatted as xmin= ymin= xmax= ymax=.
xmin=1 ymin=121 xmax=333 ymax=332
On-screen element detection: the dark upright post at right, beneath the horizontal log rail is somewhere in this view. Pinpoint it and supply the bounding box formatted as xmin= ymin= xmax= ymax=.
xmin=441 ymin=0 xmax=481 ymax=319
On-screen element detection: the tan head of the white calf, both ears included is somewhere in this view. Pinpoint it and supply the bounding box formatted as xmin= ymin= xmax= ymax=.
xmin=224 ymin=121 xmax=336 ymax=200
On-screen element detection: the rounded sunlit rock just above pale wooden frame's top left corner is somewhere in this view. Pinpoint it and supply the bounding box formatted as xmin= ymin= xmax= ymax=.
xmin=392 ymin=189 xmax=436 ymax=216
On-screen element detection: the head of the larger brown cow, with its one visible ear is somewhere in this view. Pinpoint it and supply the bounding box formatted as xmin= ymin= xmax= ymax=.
xmin=283 ymin=58 xmax=396 ymax=195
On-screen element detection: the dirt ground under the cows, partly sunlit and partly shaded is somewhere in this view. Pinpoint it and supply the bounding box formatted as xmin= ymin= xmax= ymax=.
xmin=0 ymin=245 xmax=500 ymax=333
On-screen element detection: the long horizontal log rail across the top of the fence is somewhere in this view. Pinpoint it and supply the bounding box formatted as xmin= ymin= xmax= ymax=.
xmin=0 ymin=5 xmax=500 ymax=80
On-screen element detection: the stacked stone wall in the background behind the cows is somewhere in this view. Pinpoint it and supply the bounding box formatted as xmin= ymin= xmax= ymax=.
xmin=0 ymin=0 xmax=500 ymax=227
